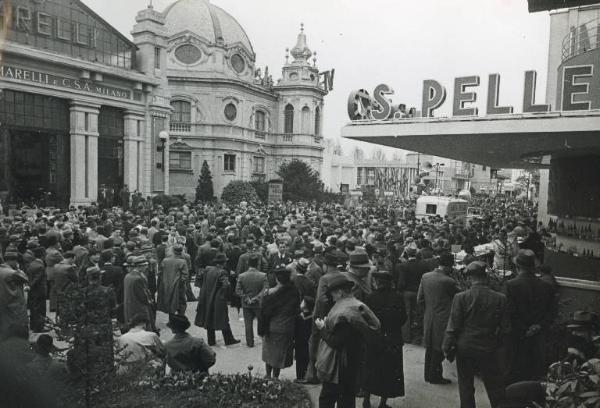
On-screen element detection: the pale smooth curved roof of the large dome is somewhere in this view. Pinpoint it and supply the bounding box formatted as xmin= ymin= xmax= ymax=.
xmin=163 ymin=0 xmax=255 ymax=59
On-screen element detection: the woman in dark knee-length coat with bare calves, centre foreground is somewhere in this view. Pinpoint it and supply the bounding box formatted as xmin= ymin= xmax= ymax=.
xmin=258 ymin=268 xmax=300 ymax=378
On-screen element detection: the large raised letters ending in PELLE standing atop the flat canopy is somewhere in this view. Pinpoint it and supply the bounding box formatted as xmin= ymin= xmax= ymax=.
xmin=348 ymin=66 xmax=593 ymax=121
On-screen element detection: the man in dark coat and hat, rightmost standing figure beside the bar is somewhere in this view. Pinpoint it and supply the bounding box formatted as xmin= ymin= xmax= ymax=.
xmin=506 ymin=249 xmax=557 ymax=384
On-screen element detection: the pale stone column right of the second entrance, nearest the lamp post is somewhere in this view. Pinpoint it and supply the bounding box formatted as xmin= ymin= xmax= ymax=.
xmin=123 ymin=111 xmax=146 ymax=192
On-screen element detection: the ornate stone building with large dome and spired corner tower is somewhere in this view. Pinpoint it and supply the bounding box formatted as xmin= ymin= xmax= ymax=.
xmin=133 ymin=0 xmax=327 ymax=198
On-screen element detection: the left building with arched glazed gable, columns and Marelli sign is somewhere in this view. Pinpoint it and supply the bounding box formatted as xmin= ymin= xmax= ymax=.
xmin=0 ymin=0 xmax=170 ymax=205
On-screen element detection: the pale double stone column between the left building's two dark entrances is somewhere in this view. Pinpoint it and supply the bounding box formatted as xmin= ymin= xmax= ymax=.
xmin=70 ymin=101 xmax=100 ymax=206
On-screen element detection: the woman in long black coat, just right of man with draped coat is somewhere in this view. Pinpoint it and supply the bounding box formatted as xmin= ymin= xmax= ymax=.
xmin=363 ymin=271 xmax=406 ymax=408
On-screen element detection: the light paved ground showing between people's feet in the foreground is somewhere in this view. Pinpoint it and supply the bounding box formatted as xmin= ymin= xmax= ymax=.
xmin=157 ymin=294 xmax=490 ymax=408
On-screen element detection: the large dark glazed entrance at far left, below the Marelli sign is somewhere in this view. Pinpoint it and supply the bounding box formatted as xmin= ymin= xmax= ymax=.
xmin=0 ymin=90 xmax=70 ymax=207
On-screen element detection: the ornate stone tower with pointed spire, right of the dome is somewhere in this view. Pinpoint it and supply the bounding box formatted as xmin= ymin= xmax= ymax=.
xmin=274 ymin=24 xmax=327 ymax=171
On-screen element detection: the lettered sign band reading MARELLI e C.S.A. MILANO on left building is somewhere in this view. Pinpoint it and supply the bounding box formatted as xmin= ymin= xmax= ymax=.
xmin=0 ymin=65 xmax=131 ymax=99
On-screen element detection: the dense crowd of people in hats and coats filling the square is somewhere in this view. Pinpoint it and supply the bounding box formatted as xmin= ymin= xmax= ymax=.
xmin=0 ymin=197 xmax=596 ymax=408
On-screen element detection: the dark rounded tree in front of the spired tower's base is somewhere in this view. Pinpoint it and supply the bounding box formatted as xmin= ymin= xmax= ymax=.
xmin=277 ymin=159 xmax=323 ymax=201
